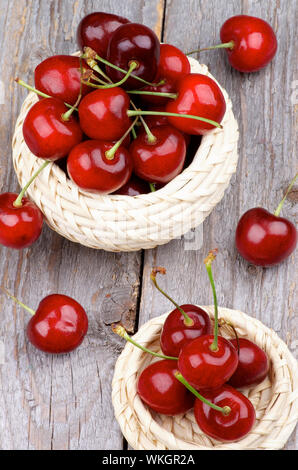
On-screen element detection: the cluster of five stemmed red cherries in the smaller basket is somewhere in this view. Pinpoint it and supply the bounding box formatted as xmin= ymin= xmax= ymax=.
xmin=113 ymin=250 xmax=269 ymax=442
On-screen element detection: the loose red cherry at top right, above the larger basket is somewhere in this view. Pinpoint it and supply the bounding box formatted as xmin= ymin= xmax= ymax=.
xmin=220 ymin=15 xmax=277 ymax=72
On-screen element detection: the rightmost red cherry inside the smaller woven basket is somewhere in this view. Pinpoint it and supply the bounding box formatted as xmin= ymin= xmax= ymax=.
xmin=229 ymin=338 xmax=269 ymax=388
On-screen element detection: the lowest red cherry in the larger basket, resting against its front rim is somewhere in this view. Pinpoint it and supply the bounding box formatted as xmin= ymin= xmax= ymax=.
xmin=67 ymin=140 xmax=132 ymax=194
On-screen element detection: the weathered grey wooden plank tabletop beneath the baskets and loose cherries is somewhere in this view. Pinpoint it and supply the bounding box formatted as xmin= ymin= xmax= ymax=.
xmin=0 ymin=0 xmax=298 ymax=449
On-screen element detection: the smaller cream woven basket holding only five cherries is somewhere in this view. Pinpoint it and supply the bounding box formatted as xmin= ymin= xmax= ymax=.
xmin=112 ymin=306 xmax=298 ymax=450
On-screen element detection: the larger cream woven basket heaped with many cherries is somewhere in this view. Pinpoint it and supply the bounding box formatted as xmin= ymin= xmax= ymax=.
xmin=12 ymin=59 xmax=238 ymax=251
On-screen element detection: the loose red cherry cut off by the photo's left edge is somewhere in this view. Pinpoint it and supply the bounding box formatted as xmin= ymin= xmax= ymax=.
xmin=0 ymin=193 xmax=43 ymax=250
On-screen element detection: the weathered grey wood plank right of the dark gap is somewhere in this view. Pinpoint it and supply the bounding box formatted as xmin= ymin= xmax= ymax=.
xmin=139 ymin=0 xmax=298 ymax=449
